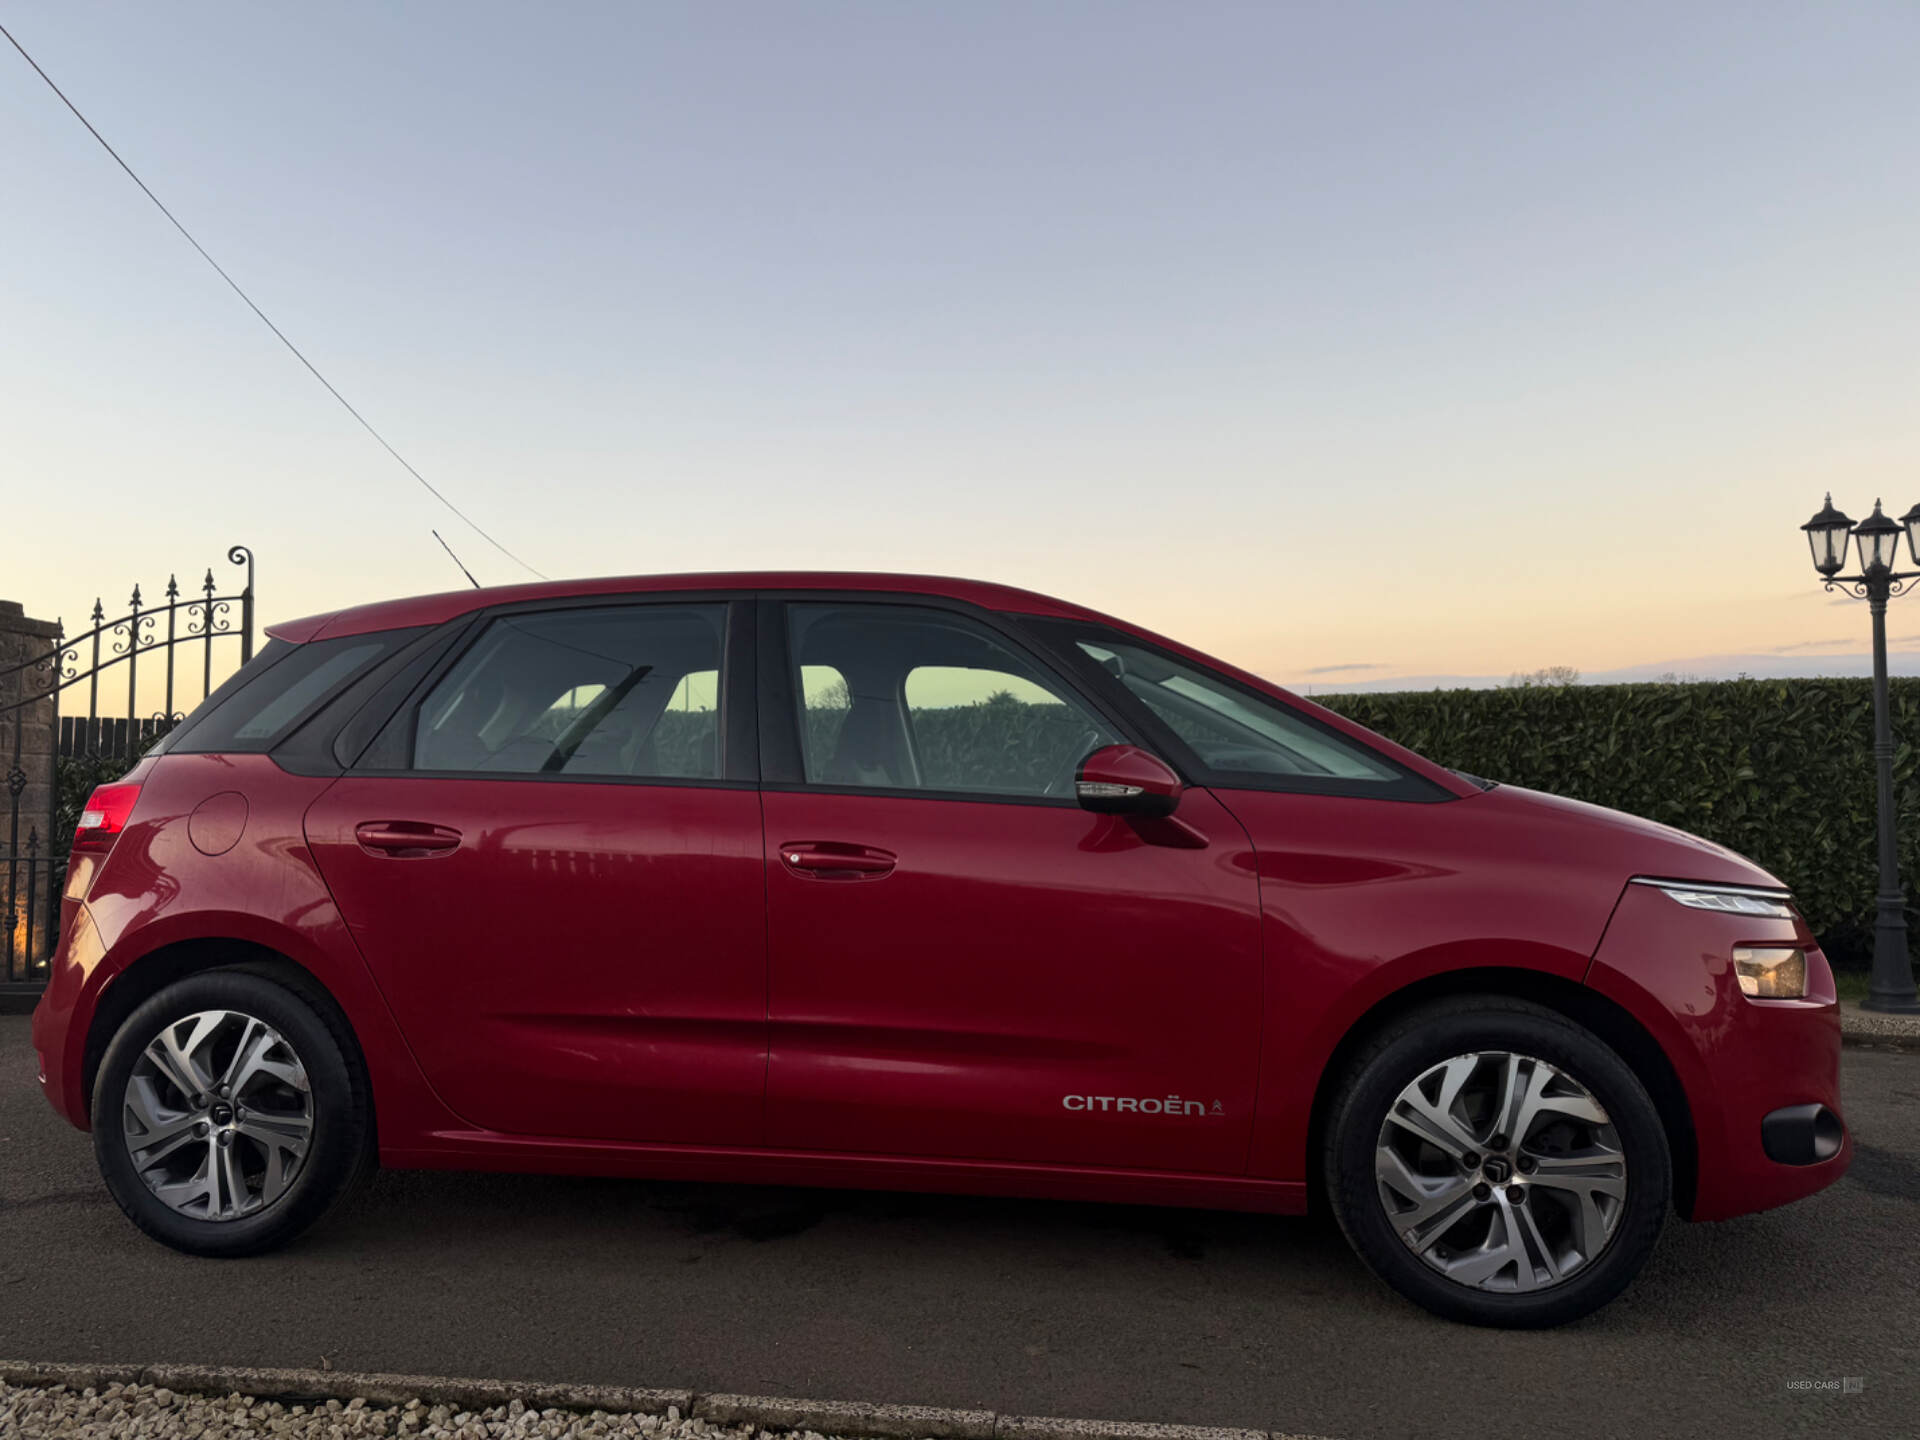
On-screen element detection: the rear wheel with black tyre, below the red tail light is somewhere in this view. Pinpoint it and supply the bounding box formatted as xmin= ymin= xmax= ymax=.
xmin=92 ymin=968 xmax=372 ymax=1256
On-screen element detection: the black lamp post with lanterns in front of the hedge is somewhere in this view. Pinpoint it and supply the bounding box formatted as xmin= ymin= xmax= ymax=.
xmin=1801 ymin=495 xmax=1920 ymax=1016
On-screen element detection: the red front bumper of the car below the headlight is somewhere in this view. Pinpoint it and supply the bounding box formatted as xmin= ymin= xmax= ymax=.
xmin=1588 ymin=885 xmax=1853 ymax=1219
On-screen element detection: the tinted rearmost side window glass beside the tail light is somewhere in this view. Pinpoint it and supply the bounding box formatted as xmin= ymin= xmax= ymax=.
xmin=167 ymin=630 xmax=419 ymax=755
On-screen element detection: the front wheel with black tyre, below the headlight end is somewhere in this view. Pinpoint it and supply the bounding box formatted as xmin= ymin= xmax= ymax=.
xmin=1325 ymin=995 xmax=1672 ymax=1329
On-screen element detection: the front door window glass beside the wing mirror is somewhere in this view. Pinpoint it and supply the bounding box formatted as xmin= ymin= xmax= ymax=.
xmin=789 ymin=605 xmax=1114 ymax=799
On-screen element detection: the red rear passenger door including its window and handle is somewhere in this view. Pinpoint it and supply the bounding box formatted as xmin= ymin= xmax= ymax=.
xmin=305 ymin=595 xmax=766 ymax=1146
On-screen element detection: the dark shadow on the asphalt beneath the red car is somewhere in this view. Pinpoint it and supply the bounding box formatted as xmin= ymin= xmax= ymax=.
xmin=290 ymin=1154 xmax=1889 ymax=1338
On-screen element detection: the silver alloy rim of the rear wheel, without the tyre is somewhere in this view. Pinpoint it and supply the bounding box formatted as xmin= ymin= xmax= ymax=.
xmin=123 ymin=1010 xmax=313 ymax=1221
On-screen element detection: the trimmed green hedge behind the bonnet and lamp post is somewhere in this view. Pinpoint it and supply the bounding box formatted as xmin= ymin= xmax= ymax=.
xmin=1315 ymin=680 xmax=1920 ymax=968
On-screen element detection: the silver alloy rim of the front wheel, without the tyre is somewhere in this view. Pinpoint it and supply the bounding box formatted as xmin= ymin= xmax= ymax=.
xmin=1375 ymin=1050 xmax=1626 ymax=1292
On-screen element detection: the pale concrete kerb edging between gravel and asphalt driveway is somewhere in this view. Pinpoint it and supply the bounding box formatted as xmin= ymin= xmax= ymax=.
xmin=0 ymin=1361 xmax=1336 ymax=1440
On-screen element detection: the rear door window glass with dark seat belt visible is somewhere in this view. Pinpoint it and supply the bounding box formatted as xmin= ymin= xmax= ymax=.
xmin=413 ymin=605 xmax=726 ymax=780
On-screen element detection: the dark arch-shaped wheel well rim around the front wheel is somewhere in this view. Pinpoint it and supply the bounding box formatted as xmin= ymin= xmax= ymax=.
xmin=1308 ymin=966 xmax=1699 ymax=1215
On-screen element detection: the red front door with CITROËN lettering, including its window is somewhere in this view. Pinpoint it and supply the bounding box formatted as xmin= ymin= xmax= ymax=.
xmin=760 ymin=601 xmax=1261 ymax=1173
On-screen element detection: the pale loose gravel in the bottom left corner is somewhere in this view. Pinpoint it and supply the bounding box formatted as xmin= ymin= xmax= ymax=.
xmin=0 ymin=1380 xmax=817 ymax=1440
